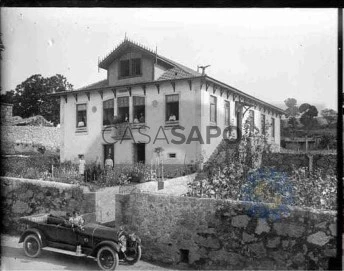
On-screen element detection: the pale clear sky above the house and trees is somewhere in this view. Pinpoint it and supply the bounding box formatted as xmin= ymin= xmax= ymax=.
xmin=0 ymin=8 xmax=337 ymax=110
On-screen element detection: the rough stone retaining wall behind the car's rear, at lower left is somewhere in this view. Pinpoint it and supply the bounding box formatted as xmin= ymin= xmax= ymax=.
xmin=0 ymin=177 xmax=95 ymax=234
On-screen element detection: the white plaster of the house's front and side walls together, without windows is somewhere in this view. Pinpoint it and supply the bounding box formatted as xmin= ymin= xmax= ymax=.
xmin=60 ymin=79 xmax=280 ymax=164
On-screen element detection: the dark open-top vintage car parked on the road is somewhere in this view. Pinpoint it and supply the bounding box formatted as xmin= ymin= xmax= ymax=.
xmin=19 ymin=214 xmax=141 ymax=270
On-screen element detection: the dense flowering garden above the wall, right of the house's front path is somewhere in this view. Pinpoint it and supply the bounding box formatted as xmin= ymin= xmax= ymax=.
xmin=186 ymin=121 xmax=337 ymax=211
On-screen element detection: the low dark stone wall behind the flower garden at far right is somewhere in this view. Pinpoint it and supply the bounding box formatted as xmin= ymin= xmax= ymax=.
xmin=262 ymin=153 xmax=337 ymax=172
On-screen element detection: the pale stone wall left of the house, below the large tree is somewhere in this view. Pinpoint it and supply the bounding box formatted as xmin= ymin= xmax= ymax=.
xmin=1 ymin=125 xmax=60 ymax=154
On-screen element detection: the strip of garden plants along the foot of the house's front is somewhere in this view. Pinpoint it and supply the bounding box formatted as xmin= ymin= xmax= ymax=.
xmin=0 ymin=152 xmax=196 ymax=191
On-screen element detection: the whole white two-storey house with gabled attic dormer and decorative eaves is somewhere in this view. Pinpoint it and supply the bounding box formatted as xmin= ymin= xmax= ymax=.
xmin=51 ymin=38 xmax=284 ymax=167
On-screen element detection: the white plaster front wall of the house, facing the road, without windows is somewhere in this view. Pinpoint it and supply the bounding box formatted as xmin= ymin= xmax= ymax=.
xmin=61 ymin=80 xmax=200 ymax=164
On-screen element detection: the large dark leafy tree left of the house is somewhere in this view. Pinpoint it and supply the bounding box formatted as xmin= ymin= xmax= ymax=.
xmin=1 ymin=74 xmax=73 ymax=125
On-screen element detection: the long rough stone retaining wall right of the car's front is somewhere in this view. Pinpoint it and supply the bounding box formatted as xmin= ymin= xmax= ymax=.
xmin=115 ymin=193 xmax=336 ymax=269
